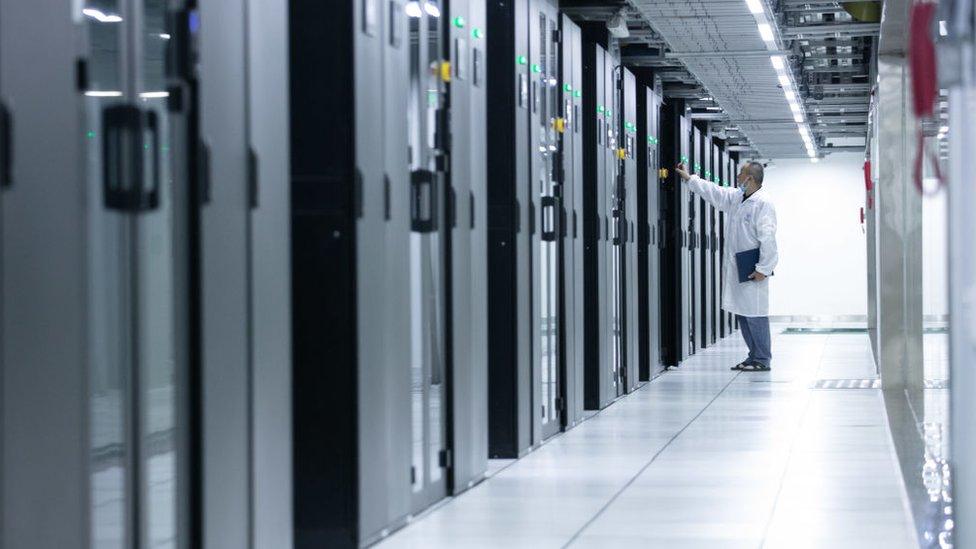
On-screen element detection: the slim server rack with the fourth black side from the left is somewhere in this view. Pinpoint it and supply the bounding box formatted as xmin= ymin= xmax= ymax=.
xmin=636 ymin=77 xmax=666 ymax=381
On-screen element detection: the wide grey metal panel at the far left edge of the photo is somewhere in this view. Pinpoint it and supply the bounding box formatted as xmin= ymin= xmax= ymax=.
xmin=0 ymin=0 xmax=88 ymax=549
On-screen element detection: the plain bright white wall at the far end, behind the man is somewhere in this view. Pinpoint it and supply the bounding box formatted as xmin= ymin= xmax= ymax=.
xmin=763 ymin=153 xmax=867 ymax=316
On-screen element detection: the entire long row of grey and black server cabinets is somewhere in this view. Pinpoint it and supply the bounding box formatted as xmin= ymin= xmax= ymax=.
xmin=0 ymin=0 xmax=735 ymax=549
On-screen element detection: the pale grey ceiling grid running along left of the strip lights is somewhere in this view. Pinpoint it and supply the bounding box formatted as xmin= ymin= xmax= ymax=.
xmin=632 ymin=0 xmax=812 ymax=159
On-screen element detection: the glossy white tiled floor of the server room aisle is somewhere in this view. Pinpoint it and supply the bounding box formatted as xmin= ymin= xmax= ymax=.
xmin=381 ymin=326 xmax=915 ymax=549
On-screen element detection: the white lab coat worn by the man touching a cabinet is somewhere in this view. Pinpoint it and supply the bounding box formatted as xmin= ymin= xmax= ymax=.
xmin=687 ymin=175 xmax=779 ymax=316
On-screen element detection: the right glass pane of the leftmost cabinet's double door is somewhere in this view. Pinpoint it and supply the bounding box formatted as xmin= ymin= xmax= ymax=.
xmin=135 ymin=0 xmax=177 ymax=547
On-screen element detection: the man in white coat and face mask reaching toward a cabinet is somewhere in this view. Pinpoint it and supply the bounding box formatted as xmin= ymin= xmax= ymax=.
xmin=676 ymin=162 xmax=779 ymax=372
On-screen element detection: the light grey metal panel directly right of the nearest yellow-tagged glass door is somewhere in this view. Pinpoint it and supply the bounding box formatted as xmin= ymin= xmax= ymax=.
xmin=454 ymin=0 xmax=488 ymax=493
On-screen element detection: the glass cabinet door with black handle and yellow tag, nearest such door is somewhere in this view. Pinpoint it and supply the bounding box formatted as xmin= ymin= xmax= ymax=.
xmin=402 ymin=0 xmax=454 ymax=511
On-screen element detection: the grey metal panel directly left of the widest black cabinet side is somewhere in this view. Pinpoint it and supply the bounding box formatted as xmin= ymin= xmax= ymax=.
xmin=246 ymin=0 xmax=293 ymax=548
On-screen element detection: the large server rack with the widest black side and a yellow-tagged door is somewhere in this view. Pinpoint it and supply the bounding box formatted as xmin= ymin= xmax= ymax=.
xmin=289 ymin=0 xmax=486 ymax=547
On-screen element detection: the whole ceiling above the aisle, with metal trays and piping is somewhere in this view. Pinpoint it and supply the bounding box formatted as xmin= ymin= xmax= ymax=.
xmin=561 ymin=0 xmax=879 ymax=159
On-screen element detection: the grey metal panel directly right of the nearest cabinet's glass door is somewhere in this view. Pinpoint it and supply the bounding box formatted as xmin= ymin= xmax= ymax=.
xmin=200 ymin=0 xmax=251 ymax=547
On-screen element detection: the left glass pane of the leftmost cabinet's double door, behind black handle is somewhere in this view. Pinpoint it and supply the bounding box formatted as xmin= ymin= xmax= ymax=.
xmin=85 ymin=0 xmax=131 ymax=549
